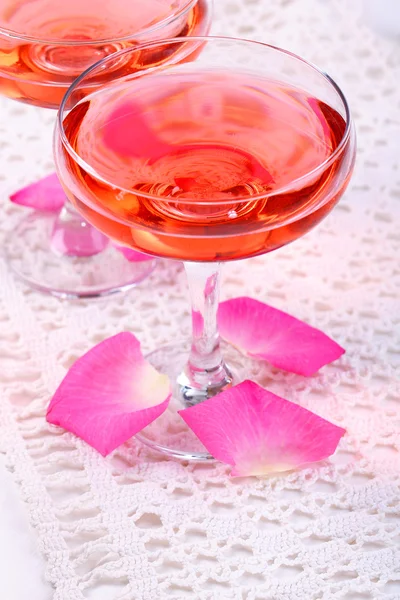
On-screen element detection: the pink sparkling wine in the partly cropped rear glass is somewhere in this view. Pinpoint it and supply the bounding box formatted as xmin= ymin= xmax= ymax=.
xmin=0 ymin=0 xmax=210 ymax=108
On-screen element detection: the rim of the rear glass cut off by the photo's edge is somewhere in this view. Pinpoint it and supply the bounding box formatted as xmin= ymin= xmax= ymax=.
xmin=0 ymin=0 xmax=196 ymax=45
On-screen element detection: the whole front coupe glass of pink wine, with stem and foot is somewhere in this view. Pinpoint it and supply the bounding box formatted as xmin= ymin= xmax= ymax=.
xmin=55 ymin=37 xmax=356 ymax=460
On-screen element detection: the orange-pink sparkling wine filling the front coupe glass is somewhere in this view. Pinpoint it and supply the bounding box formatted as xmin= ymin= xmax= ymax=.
xmin=60 ymin=64 xmax=353 ymax=261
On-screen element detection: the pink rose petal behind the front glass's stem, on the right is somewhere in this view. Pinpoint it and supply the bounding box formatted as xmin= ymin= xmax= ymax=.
xmin=218 ymin=297 xmax=345 ymax=376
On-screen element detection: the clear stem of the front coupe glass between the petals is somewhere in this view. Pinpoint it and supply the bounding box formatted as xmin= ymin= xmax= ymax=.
xmin=178 ymin=262 xmax=232 ymax=405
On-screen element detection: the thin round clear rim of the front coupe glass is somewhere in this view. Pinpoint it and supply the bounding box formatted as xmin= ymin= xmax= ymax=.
xmin=55 ymin=36 xmax=353 ymax=206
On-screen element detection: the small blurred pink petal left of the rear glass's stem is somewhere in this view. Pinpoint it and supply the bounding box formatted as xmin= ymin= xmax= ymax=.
xmin=10 ymin=173 xmax=66 ymax=212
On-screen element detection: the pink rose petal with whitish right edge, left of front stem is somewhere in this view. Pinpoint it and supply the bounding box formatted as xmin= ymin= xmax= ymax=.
xmin=46 ymin=333 xmax=170 ymax=456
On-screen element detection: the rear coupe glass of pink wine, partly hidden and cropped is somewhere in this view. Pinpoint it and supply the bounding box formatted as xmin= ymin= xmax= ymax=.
xmin=0 ymin=0 xmax=212 ymax=297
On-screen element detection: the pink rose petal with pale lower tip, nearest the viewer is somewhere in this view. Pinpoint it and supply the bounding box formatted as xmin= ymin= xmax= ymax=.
xmin=179 ymin=381 xmax=345 ymax=476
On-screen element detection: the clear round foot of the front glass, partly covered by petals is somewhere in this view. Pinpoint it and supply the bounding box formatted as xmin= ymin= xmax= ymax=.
xmin=136 ymin=341 xmax=252 ymax=462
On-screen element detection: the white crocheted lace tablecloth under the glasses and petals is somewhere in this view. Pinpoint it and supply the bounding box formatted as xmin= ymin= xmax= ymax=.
xmin=0 ymin=0 xmax=400 ymax=600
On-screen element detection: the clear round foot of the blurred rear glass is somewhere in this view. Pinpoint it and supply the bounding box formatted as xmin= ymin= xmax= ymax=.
xmin=5 ymin=212 xmax=157 ymax=298
